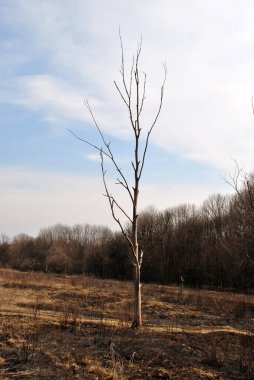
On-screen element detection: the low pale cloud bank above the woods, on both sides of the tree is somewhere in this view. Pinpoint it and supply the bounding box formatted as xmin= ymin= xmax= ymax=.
xmin=0 ymin=167 xmax=229 ymax=236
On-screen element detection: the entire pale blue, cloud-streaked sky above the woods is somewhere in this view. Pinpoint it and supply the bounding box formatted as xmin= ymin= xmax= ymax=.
xmin=0 ymin=0 xmax=254 ymax=237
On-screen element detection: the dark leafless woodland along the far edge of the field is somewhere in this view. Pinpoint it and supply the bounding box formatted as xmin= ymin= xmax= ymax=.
xmin=0 ymin=176 xmax=254 ymax=291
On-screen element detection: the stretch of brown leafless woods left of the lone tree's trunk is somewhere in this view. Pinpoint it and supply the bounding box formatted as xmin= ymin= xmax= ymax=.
xmin=0 ymin=224 xmax=131 ymax=279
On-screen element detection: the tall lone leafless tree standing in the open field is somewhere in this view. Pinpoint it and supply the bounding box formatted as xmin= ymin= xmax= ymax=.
xmin=70 ymin=33 xmax=167 ymax=328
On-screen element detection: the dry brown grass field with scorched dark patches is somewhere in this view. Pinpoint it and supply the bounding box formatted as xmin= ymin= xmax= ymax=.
xmin=0 ymin=270 xmax=254 ymax=379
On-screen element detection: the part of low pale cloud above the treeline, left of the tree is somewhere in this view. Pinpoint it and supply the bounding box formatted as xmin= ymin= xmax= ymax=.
xmin=0 ymin=167 xmax=112 ymax=236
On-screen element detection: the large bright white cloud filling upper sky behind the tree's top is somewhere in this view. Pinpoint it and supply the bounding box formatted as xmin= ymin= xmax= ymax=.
xmin=0 ymin=0 xmax=254 ymax=180
